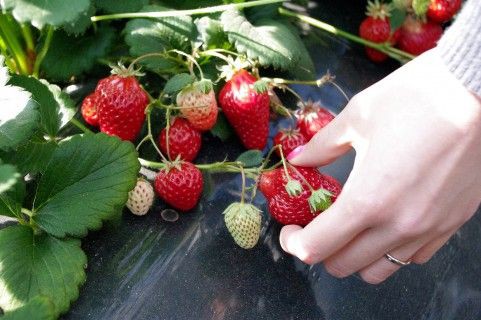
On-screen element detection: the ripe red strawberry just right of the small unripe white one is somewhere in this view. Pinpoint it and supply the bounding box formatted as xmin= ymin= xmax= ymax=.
xmin=155 ymin=161 xmax=203 ymax=211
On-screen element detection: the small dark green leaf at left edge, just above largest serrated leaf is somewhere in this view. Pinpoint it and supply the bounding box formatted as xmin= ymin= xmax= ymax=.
xmin=1 ymin=139 xmax=57 ymax=175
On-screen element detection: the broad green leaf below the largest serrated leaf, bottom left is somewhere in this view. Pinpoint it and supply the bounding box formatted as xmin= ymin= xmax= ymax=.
xmin=0 ymin=225 xmax=87 ymax=315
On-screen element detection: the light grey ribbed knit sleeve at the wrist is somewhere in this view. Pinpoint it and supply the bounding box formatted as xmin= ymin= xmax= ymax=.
xmin=435 ymin=0 xmax=481 ymax=97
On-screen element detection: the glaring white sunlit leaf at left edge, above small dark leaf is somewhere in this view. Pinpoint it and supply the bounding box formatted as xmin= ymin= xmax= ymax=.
xmin=0 ymin=55 xmax=40 ymax=150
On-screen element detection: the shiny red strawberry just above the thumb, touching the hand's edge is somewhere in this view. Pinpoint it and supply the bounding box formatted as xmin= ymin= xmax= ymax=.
xmin=296 ymin=100 xmax=334 ymax=141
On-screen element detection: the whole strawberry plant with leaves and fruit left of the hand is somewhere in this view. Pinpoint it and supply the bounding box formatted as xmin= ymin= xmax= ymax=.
xmin=0 ymin=0 xmax=356 ymax=319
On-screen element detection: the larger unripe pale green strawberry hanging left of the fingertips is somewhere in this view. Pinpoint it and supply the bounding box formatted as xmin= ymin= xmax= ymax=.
xmin=224 ymin=202 xmax=262 ymax=249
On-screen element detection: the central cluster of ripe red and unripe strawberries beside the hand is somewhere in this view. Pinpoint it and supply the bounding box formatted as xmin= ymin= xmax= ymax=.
xmin=81 ymin=68 xmax=341 ymax=248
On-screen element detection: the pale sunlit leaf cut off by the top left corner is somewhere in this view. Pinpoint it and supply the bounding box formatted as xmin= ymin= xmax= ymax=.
xmin=2 ymin=0 xmax=90 ymax=29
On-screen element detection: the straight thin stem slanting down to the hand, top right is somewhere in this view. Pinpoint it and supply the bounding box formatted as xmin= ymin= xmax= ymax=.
xmin=279 ymin=8 xmax=415 ymax=62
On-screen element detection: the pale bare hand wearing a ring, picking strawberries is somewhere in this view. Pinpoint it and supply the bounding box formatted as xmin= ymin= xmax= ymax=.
xmin=280 ymin=49 xmax=481 ymax=284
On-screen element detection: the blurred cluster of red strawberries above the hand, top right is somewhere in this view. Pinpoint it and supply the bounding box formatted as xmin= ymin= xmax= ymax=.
xmin=359 ymin=0 xmax=461 ymax=62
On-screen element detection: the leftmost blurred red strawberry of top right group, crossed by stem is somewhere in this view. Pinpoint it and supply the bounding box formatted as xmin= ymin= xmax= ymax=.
xmin=359 ymin=0 xmax=391 ymax=62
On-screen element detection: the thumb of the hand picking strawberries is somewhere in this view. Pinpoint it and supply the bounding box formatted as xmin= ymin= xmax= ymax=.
xmin=287 ymin=113 xmax=351 ymax=167
